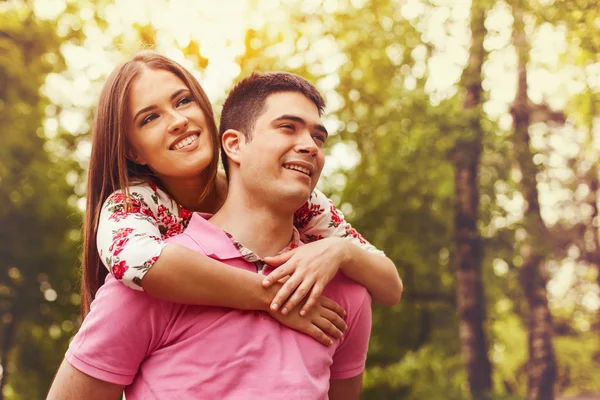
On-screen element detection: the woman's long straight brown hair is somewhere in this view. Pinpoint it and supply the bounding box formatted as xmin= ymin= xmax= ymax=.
xmin=81 ymin=51 xmax=219 ymax=319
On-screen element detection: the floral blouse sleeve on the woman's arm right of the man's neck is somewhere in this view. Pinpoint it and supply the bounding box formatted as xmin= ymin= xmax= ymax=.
xmin=294 ymin=189 xmax=385 ymax=255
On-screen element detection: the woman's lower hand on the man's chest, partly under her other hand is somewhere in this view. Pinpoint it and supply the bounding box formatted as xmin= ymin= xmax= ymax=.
xmin=269 ymin=297 xmax=348 ymax=346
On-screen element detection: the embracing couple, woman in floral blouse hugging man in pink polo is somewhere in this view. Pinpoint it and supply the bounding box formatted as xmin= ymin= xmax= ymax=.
xmin=48 ymin=52 xmax=402 ymax=400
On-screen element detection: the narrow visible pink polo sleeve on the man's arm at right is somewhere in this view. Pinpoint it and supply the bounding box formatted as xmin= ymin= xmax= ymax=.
xmin=330 ymin=290 xmax=372 ymax=379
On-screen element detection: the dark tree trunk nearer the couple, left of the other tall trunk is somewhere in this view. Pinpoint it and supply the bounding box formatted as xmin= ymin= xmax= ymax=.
xmin=453 ymin=1 xmax=492 ymax=399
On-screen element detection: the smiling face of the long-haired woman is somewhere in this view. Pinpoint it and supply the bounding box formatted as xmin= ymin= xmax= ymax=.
xmin=127 ymin=68 xmax=215 ymax=185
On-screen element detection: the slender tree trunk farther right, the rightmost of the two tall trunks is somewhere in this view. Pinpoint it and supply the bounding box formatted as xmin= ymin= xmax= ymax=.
xmin=511 ymin=1 xmax=556 ymax=400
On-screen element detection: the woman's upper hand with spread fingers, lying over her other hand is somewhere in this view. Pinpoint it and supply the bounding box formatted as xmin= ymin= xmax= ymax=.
xmin=263 ymin=237 xmax=347 ymax=316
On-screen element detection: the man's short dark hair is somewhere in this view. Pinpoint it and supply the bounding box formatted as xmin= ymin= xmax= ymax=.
xmin=219 ymin=72 xmax=325 ymax=175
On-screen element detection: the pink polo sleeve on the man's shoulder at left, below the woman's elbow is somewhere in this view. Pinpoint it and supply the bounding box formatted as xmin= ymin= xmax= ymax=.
xmin=65 ymin=276 xmax=168 ymax=385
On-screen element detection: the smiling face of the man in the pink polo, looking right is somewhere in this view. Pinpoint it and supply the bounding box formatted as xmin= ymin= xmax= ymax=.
xmin=240 ymin=92 xmax=327 ymax=208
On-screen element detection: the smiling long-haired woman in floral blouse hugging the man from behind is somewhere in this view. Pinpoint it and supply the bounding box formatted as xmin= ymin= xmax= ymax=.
xmin=82 ymin=52 xmax=402 ymax=342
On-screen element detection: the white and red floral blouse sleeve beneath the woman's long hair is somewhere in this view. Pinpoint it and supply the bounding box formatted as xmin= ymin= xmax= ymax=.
xmin=96 ymin=185 xmax=184 ymax=290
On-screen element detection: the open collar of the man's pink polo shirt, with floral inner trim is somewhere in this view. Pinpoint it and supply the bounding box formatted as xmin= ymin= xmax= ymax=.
xmin=185 ymin=213 xmax=302 ymax=262
